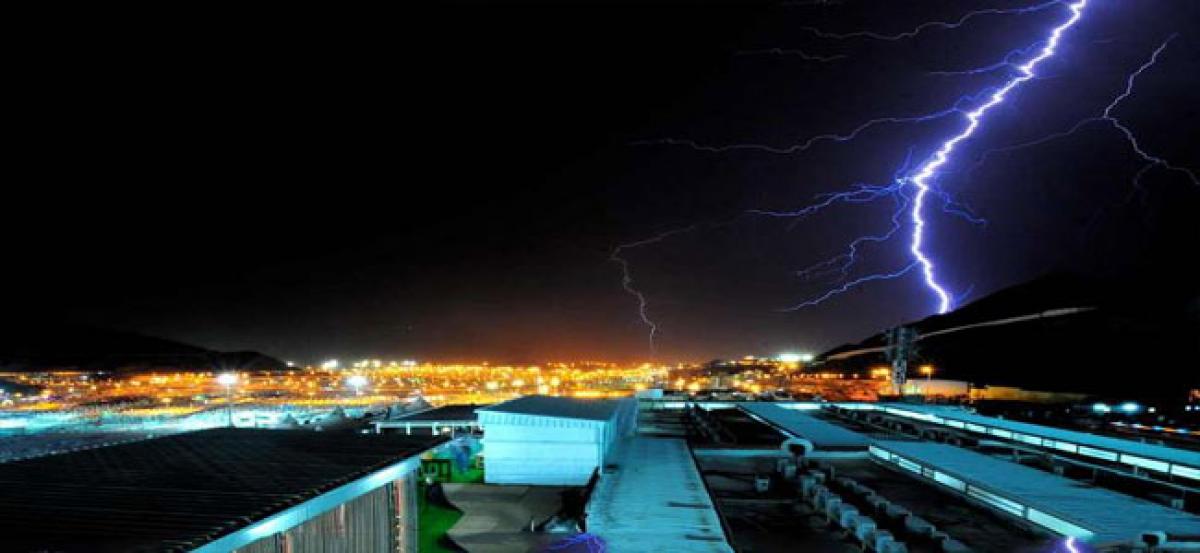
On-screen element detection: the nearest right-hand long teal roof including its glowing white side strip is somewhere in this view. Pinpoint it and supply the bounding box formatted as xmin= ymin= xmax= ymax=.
xmin=871 ymin=440 xmax=1200 ymax=545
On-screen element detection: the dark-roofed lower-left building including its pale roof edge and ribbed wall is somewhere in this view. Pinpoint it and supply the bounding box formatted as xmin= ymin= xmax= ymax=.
xmin=0 ymin=428 xmax=445 ymax=553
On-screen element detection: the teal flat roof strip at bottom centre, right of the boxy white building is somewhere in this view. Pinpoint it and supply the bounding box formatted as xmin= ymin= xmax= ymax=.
xmin=587 ymin=437 xmax=733 ymax=553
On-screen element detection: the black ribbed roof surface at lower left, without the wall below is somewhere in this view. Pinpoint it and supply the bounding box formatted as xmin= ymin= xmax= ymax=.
xmin=0 ymin=428 xmax=445 ymax=552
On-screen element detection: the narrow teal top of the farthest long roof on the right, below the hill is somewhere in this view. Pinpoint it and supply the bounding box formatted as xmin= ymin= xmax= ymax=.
xmin=881 ymin=403 xmax=1200 ymax=469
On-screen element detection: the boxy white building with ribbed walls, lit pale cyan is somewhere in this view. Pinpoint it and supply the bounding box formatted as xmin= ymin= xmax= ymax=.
xmin=476 ymin=396 xmax=637 ymax=486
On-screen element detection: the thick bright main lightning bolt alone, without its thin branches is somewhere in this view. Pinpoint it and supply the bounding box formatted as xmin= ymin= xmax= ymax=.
xmin=907 ymin=0 xmax=1087 ymax=313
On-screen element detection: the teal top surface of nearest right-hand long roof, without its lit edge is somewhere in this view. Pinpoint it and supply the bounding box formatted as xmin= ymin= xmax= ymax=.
xmin=874 ymin=440 xmax=1200 ymax=543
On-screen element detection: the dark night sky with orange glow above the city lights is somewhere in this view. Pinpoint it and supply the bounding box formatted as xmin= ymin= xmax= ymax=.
xmin=9 ymin=0 xmax=1200 ymax=361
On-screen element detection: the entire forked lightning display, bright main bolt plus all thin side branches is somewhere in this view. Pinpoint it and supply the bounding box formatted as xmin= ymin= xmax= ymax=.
xmin=612 ymin=0 xmax=1200 ymax=348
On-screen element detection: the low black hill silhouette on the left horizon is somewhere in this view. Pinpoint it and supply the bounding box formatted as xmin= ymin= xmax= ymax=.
xmin=0 ymin=321 xmax=284 ymax=372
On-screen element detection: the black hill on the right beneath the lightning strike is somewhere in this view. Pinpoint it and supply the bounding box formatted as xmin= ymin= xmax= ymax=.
xmin=818 ymin=275 xmax=1200 ymax=399
